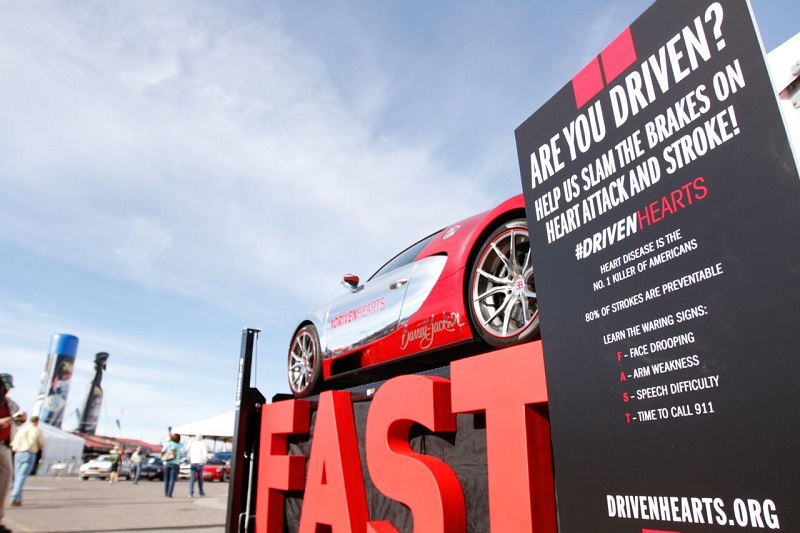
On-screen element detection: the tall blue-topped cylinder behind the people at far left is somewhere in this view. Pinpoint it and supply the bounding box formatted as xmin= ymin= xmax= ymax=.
xmin=34 ymin=333 xmax=78 ymax=428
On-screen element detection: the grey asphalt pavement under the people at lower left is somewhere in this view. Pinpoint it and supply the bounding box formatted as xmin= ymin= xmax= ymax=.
xmin=3 ymin=476 xmax=229 ymax=533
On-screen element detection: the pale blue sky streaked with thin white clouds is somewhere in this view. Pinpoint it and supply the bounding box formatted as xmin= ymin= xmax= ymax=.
xmin=0 ymin=0 xmax=800 ymax=442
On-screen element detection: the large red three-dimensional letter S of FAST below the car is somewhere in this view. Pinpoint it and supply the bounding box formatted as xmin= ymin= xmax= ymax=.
xmin=366 ymin=376 xmax=467 ymax=533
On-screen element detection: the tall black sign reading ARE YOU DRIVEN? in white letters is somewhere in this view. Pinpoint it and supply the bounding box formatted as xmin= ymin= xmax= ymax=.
xmin=516 ymin=0 xmax=800 ymax=533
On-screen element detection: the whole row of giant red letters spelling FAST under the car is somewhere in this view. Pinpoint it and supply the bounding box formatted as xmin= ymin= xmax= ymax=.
xmin=255 ymin=342 xmax=556 ymax=533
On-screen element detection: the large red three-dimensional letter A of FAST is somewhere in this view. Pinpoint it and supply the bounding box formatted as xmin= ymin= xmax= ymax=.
xmin=299 ymin=391 xmax=369 ymax=533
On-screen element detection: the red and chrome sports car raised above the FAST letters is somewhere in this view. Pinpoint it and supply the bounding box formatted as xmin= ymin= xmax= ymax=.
xmin=287 ymin=195 xmax=539 ymax=398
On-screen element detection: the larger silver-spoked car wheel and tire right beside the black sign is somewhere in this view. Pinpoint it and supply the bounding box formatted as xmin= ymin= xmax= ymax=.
xmin=466 ymin=218 xmax=539 ymax=348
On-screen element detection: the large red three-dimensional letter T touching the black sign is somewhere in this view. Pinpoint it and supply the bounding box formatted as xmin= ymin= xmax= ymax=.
xmin=450 ymin=342 xmax=556 ymax=533
